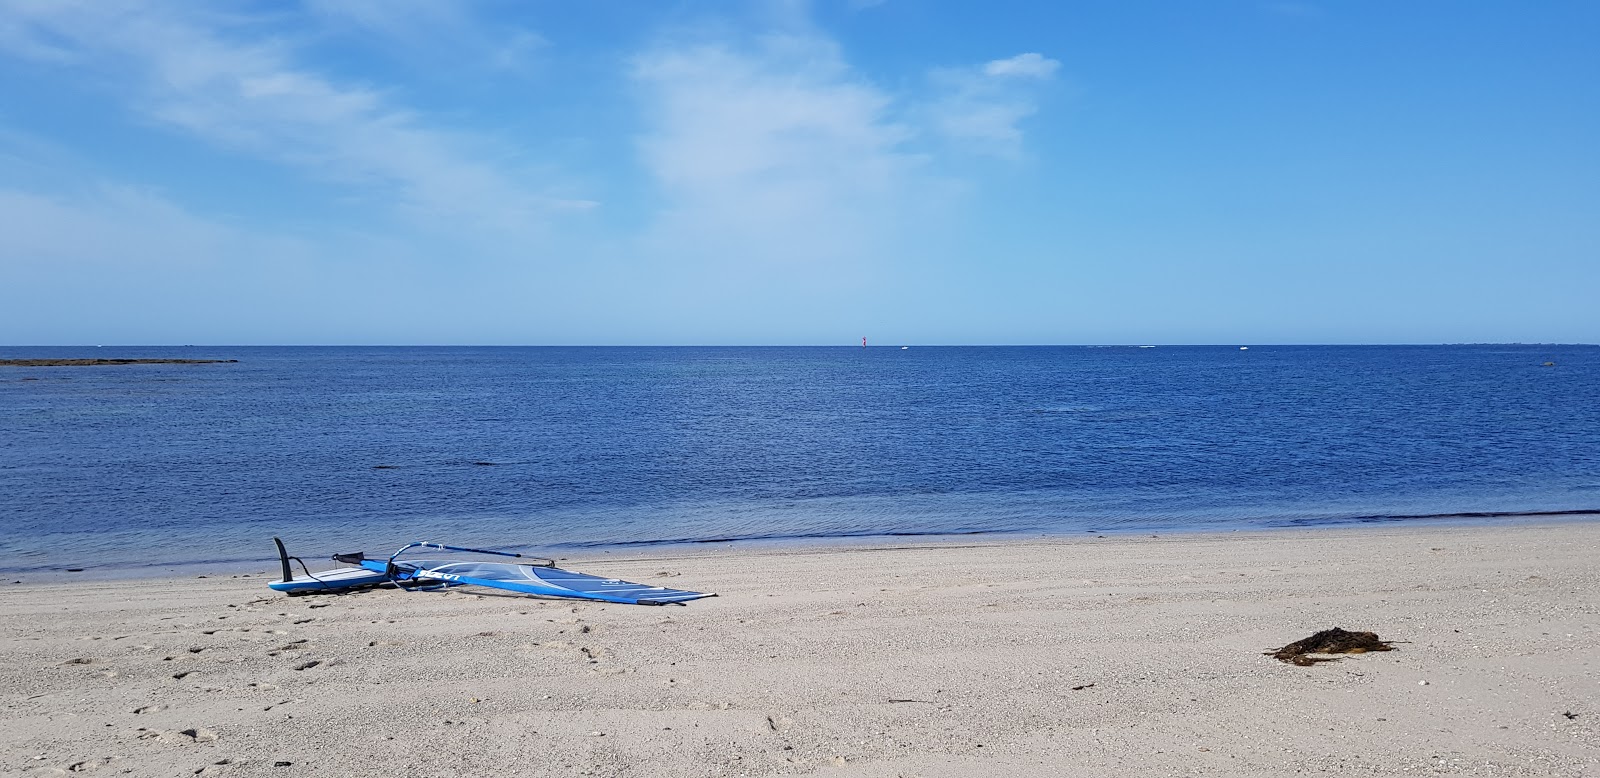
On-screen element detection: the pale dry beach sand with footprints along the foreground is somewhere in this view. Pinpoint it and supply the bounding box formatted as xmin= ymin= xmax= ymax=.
xmin=0 ymin=522 xmax=1600 ymax=778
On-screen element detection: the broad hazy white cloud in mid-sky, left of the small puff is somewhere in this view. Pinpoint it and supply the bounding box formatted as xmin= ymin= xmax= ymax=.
xmin=634 ymin=34 xmax=933 ymax=280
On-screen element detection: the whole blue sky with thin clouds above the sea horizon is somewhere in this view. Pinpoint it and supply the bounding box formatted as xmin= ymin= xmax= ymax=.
xmin=0 ymin=0 xmax=1600 ymax=346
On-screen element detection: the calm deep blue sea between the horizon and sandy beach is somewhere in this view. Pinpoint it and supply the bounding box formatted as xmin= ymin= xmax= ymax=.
xmin=0 ymin=346 xmax=1600 ymax=575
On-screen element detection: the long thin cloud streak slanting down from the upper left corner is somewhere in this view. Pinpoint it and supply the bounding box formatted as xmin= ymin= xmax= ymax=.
xmin=0 ymin=2 xmax=592 ymax=229
